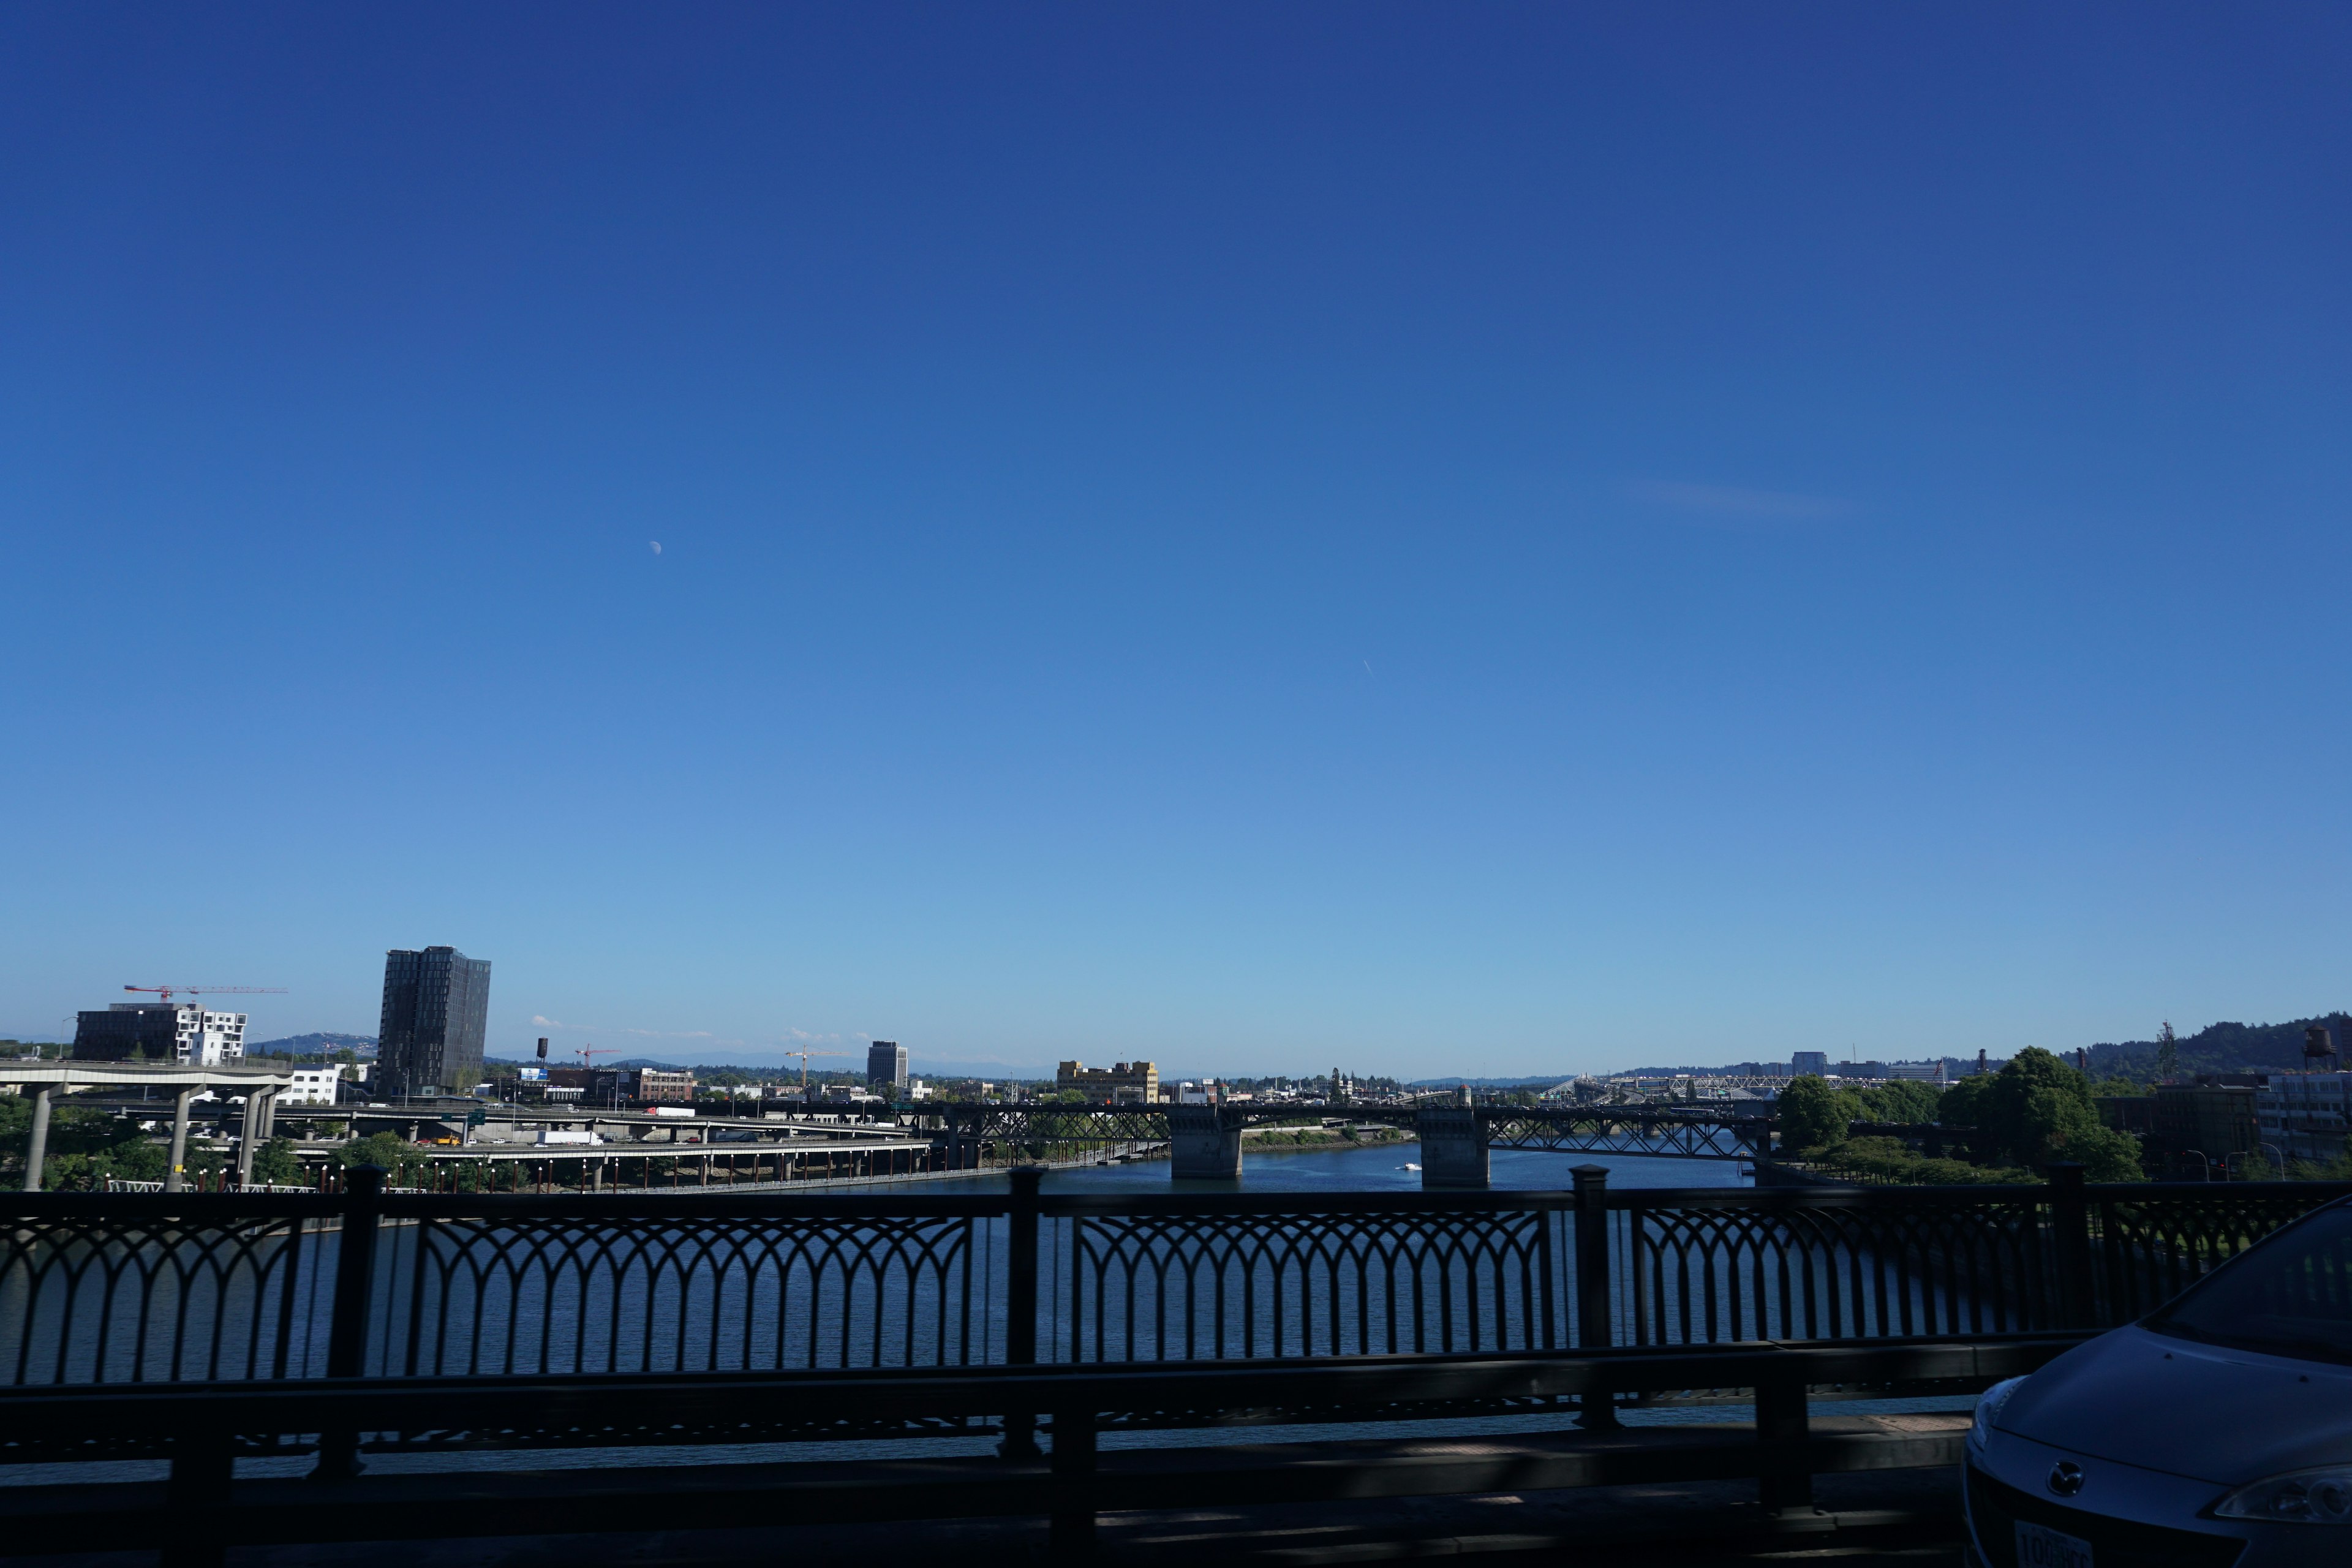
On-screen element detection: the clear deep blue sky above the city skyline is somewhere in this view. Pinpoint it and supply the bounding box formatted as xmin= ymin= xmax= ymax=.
xmin=0 ymin=5 xmax=2352 ymax=1077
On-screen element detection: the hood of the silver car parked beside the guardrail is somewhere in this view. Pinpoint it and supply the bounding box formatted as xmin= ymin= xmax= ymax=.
xmin=1992 ymin=1329 xmax=2352 ymax=1486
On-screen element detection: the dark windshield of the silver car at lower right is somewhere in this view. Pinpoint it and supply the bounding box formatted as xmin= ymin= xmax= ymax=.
xmin=2145 ymin=1206 xmax=2352 ymax=1361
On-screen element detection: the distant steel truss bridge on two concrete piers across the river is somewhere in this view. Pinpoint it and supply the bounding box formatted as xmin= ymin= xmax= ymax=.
xmin=919 ymin=1102 xmax=1773 ymax=1187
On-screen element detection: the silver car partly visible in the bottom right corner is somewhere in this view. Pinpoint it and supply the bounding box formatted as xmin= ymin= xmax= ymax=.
xmin=1964 ymin=1201 xmax=2352 ymax=1568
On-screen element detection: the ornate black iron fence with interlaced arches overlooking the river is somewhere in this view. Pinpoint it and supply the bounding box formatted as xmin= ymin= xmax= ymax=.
xmin=0 ymin=1166 xmax=2352 ymax=1385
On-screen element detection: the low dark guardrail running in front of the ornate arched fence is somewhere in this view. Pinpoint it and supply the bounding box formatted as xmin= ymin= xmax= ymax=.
xmin=0 ymin=1335 xmax=2081 ymax=1568
